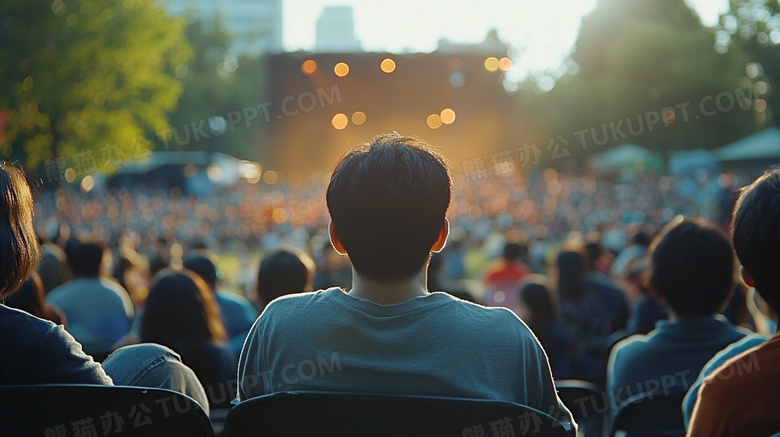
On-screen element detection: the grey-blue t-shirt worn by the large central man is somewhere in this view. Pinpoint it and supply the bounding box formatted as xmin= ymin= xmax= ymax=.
xmin=238 ymin=288 xmax=573 ymax=428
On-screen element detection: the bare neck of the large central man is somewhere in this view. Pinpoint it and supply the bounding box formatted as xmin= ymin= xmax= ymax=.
xmin=349 ymin=268 xmax=429 ymax=305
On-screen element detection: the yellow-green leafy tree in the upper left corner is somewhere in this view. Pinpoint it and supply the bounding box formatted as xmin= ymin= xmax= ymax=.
xmin=0 ymin=0 xmax=191 ymax=170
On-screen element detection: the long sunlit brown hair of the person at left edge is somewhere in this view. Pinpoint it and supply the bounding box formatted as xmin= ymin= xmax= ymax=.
xmin=0 ymin=162 xmax=40 ymax=299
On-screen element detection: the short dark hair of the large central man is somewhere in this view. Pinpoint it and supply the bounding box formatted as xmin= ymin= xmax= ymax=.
xmin=327 ymin=133 xmax=452 ymax=282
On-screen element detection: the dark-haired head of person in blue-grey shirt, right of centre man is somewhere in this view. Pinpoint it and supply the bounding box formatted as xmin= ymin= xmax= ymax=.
xmin=648 ymin=217 xmax=734 ymax=318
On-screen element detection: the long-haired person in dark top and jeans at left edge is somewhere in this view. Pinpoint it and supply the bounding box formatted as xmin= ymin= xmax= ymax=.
xmin=0 ymin=162 xmax=209 ymax=412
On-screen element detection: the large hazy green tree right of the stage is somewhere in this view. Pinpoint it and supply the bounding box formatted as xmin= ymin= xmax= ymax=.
xmin=521 ymin=0 xmax=757 ymax=164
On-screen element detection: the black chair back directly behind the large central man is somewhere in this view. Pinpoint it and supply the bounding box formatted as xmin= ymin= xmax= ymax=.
xmin=223 ymin=391 xmax=574 ymax=437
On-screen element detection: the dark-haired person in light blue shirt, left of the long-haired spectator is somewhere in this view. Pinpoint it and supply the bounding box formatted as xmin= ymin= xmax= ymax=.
xmin=46 ymin=240 xmax=133 ymax=360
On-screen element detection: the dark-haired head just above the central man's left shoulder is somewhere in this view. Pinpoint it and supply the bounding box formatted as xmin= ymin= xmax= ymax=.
xmin=257 ymin=249 xmax=314 ymax=305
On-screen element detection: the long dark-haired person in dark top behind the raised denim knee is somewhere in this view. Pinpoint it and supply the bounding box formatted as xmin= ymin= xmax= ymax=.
xmin=140 ymin=270 xmax=236 ymax=408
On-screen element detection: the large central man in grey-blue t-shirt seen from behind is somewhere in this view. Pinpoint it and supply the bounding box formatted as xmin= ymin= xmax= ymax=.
xmin=238 ymin=133 xmax=573 ymax=423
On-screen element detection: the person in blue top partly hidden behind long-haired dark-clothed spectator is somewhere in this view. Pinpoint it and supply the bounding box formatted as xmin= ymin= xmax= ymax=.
xmin=184 ymin=250 xmax=257 ymax=354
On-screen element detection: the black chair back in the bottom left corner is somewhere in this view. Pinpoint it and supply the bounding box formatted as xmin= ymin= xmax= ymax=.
xmin=0 ymin=384 xmax=214 ymax=437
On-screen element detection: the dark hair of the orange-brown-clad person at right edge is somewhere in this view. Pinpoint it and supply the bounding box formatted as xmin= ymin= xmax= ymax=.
xmin=732 ymin=168 xmax=780 ymax=313
